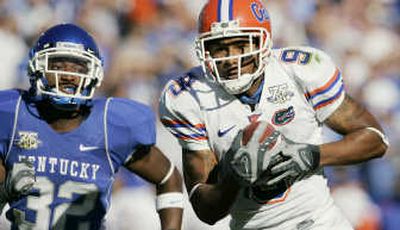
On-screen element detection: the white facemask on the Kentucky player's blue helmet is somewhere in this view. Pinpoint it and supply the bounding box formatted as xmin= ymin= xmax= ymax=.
xmin=29 ymin=43 xmax=103 ymax=108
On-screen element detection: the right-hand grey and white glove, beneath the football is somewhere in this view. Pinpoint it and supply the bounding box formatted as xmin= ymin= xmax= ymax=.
xmin=250 ymin=137 xmax=320 ymax=202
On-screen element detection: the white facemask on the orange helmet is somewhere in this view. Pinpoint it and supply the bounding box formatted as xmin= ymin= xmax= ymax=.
xmin=196 ymin=21 xmax=272 ymax=95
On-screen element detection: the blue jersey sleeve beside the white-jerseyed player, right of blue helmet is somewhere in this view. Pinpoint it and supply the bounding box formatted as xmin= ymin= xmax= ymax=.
xmin=107 ymin=98 xmax=156 ymax=164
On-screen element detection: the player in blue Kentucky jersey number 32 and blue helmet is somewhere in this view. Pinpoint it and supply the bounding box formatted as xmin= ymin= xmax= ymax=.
xmin=0 ymin=24 xmax=183 ymax=230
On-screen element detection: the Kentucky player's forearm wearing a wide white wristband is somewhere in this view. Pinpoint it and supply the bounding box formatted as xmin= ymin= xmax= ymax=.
xmin=157 ymin=168 xmax=183 ymax=230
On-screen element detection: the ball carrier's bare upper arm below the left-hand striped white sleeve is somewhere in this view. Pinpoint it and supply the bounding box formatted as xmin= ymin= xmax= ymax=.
xmin=182 ymin=149 xmax=218 ymax=190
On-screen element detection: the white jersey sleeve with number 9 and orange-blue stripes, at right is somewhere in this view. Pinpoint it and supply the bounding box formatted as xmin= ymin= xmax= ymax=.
xmin=280 ymin=47 xmax=345 ymax=122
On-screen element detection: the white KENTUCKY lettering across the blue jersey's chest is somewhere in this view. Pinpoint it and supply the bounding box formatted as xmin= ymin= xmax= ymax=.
xmin=18 ymin=155 xmax=100 ymax=180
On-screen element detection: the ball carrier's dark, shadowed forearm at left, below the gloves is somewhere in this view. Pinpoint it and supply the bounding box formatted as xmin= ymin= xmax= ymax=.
xmin=190 ymin=178 xmax=240 ymax=225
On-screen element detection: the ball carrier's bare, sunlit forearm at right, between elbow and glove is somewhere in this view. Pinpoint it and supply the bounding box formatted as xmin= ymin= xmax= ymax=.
xmin=320 ymin=128 xmax=387 ymax=166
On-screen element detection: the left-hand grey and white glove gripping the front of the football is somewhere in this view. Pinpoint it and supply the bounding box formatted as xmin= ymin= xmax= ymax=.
xmin=222 ymin=122 xmax=280 ymax=186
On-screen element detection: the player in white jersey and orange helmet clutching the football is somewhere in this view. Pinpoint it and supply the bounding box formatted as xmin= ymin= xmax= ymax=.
xmin=159 ymin=0 xmax=388 ymax=230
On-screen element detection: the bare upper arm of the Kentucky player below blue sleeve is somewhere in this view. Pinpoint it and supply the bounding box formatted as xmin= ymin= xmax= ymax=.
xmin=125 ymin=146 xmax=170 ymax=184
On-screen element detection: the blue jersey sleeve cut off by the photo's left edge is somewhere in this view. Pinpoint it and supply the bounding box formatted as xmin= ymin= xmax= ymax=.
xmin=0 ymin=90 xmax=20 ymax=160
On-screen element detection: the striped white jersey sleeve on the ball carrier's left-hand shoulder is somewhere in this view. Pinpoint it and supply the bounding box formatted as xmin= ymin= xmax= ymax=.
xmin=159 ymin=69 xmax=210 ymax=150
